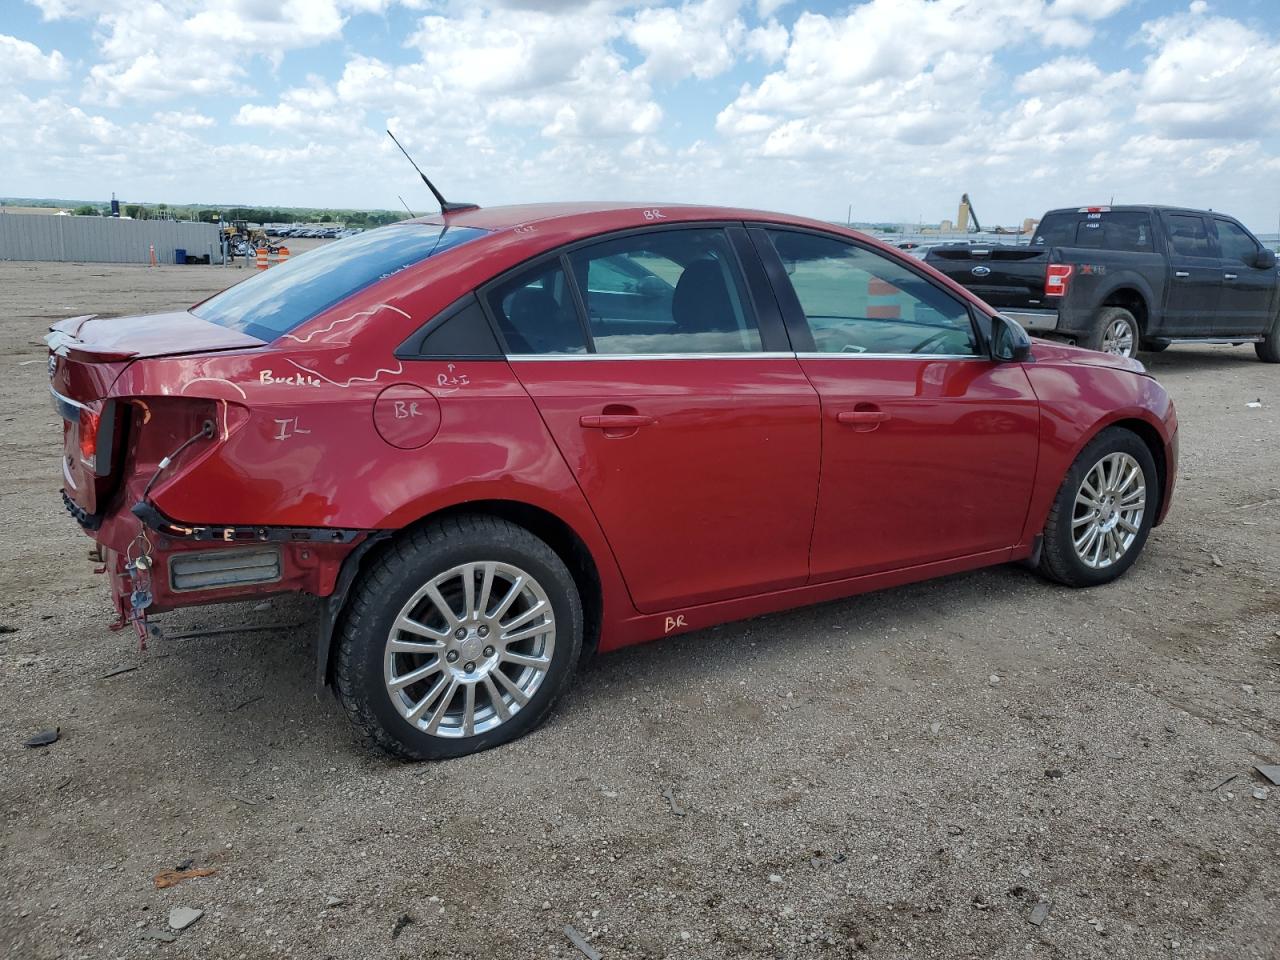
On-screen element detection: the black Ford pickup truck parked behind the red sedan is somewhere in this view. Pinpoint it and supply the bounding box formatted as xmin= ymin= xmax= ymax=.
xmin=924 ymin=206 xmax=1280 ymax=364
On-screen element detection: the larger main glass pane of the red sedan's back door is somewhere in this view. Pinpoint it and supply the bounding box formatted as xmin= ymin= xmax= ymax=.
xmin=570 ymin=229 xmax=763 ymax=353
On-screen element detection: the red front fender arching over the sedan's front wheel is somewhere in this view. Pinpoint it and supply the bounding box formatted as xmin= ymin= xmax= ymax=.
xmin=1023 ymin=360 xmax=1178 ymax=545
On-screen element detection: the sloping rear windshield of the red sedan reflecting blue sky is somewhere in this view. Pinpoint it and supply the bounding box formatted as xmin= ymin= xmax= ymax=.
xmin=191 ymin=224 xmax=485 ymax=340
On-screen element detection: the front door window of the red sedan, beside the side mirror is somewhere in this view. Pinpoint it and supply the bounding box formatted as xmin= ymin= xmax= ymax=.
xmin=769 ymin=230 xmax=978 ymax=356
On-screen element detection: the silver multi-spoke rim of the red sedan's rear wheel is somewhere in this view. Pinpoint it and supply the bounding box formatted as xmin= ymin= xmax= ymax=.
xmin=383 ymin=561 xmax=556 ymax=737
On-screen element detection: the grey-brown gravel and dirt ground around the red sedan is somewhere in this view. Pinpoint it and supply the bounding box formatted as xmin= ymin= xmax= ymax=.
xmin=0 ymin=257 xmax=1280 ymax=960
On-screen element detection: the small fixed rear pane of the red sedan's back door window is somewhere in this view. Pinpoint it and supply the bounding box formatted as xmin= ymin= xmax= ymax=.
xmin=488 ymin=260 xmax=588 ymax=356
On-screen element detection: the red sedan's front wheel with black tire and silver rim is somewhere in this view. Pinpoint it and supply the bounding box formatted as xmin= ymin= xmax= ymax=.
xmin=1039 ymin=426 xmax=1161 ymax=586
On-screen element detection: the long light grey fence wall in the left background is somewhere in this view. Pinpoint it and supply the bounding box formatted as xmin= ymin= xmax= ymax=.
xmin=0 ymin=214 xmax=221 ymax=264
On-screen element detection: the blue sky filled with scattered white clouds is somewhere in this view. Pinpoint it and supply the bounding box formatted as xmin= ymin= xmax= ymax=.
xmin=0 ymin=0 xmax=1280 ymax=233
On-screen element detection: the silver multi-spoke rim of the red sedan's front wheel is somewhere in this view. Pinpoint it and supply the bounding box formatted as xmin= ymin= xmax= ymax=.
xmin=1071 ymin=453 xmax=1147 ymax=570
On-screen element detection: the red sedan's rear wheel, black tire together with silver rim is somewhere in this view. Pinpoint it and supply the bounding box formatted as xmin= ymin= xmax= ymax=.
xmin=334 ymin=515 xmax=582 ymax=760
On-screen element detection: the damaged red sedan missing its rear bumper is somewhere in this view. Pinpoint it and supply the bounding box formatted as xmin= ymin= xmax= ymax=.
xmin=49 ymin=204 xmax=1178 ymax=758
